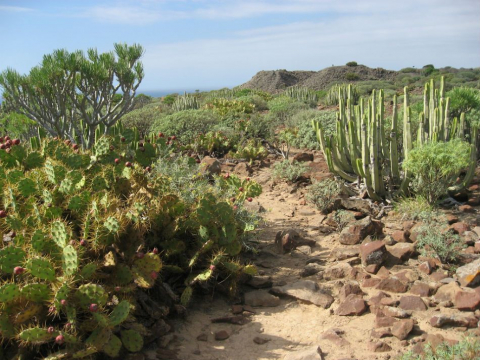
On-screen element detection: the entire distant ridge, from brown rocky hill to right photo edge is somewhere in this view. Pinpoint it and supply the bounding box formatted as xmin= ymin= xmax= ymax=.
xmin=239 ymin=65 xmax=480 ymax=93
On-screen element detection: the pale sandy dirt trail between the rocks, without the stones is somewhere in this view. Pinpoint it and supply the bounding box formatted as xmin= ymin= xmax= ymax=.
xmin=162 ymin=156 xmax=480 ymax=360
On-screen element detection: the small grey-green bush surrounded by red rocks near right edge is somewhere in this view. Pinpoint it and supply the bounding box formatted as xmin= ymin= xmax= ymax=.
xmin=417 ymin=221 xmax=464 ymax=264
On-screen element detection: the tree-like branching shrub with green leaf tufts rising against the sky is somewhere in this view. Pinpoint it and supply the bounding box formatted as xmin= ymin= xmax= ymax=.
xmin=0 ymin=44 xmax=144 ymax=148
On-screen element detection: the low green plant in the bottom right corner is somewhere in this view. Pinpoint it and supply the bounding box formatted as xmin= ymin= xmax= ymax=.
xmin=398 ymin=336 xmax=480 ymax=360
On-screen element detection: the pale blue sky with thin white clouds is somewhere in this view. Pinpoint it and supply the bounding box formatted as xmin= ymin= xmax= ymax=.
xmin=0 ymin=0 xmax=480 ymax=91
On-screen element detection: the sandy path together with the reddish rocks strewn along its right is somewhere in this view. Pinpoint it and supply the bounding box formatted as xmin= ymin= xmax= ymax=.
xmin=162 ymin=152 xmax=480 ymax=360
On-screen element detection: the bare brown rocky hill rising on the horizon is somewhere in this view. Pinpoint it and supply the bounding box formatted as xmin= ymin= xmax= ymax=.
xmin=240 ymin=65 xmax=398 ymax=93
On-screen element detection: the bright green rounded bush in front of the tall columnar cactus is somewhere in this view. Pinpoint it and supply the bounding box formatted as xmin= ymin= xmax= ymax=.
xmin=403 ymin=140 xmax=470 ymax=204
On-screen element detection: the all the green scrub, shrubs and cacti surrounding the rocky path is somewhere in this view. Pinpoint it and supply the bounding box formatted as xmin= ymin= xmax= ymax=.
xmin=0 ymin=46 xmax=480 ymax=359
